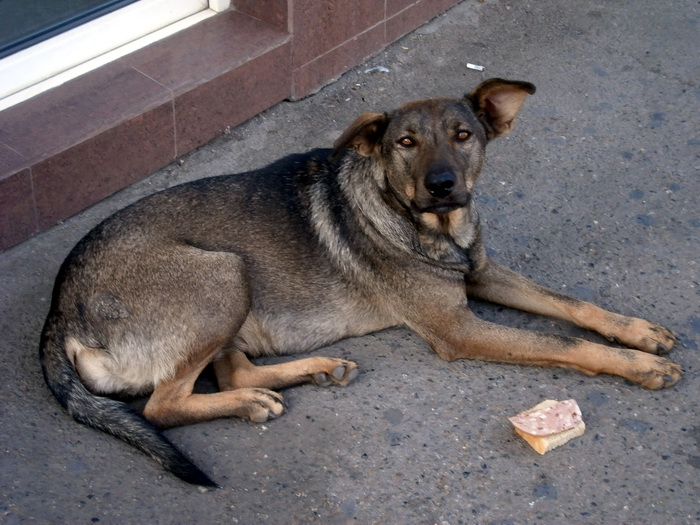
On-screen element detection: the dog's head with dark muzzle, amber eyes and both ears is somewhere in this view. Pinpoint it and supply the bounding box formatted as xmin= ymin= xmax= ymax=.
xmin=334 ymin=78 xmax=535 ymax=215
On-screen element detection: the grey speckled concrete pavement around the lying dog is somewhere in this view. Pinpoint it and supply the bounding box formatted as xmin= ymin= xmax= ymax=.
xmin=0 ymin=0 xmax=700 ymax=525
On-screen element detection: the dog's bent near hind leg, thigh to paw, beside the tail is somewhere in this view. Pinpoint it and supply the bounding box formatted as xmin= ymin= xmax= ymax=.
xmin=115 ymin=246 xmax=284 ymax=427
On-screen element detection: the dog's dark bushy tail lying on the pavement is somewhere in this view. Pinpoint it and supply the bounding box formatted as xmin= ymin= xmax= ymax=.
xmin=39 ymin=314 xmax=217 ymax=487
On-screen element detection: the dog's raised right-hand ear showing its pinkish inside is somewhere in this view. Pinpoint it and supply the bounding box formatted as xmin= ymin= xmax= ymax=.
xmin=465 ymin=78 xmax=535 ymax=140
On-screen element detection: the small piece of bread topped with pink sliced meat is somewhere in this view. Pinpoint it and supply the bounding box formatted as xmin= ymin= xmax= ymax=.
xmin=508 ymin=399 xmax=586 ymax=454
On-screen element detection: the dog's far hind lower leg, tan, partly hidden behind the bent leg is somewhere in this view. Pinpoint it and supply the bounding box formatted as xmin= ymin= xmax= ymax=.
xmin=214 ymin=351 xmax=358 ymax=391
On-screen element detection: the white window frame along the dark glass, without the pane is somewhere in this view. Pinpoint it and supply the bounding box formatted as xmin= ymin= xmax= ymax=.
xmin=0 ymin=0 xmax=230 ymax=111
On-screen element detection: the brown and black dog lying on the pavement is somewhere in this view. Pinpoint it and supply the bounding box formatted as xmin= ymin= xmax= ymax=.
xmin=40 ymin=78 xmax=682 ymax=487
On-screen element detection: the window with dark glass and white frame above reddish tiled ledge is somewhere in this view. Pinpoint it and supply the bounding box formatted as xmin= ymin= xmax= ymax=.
xmin=0 ymin=0 xmax=211 ymax=111
